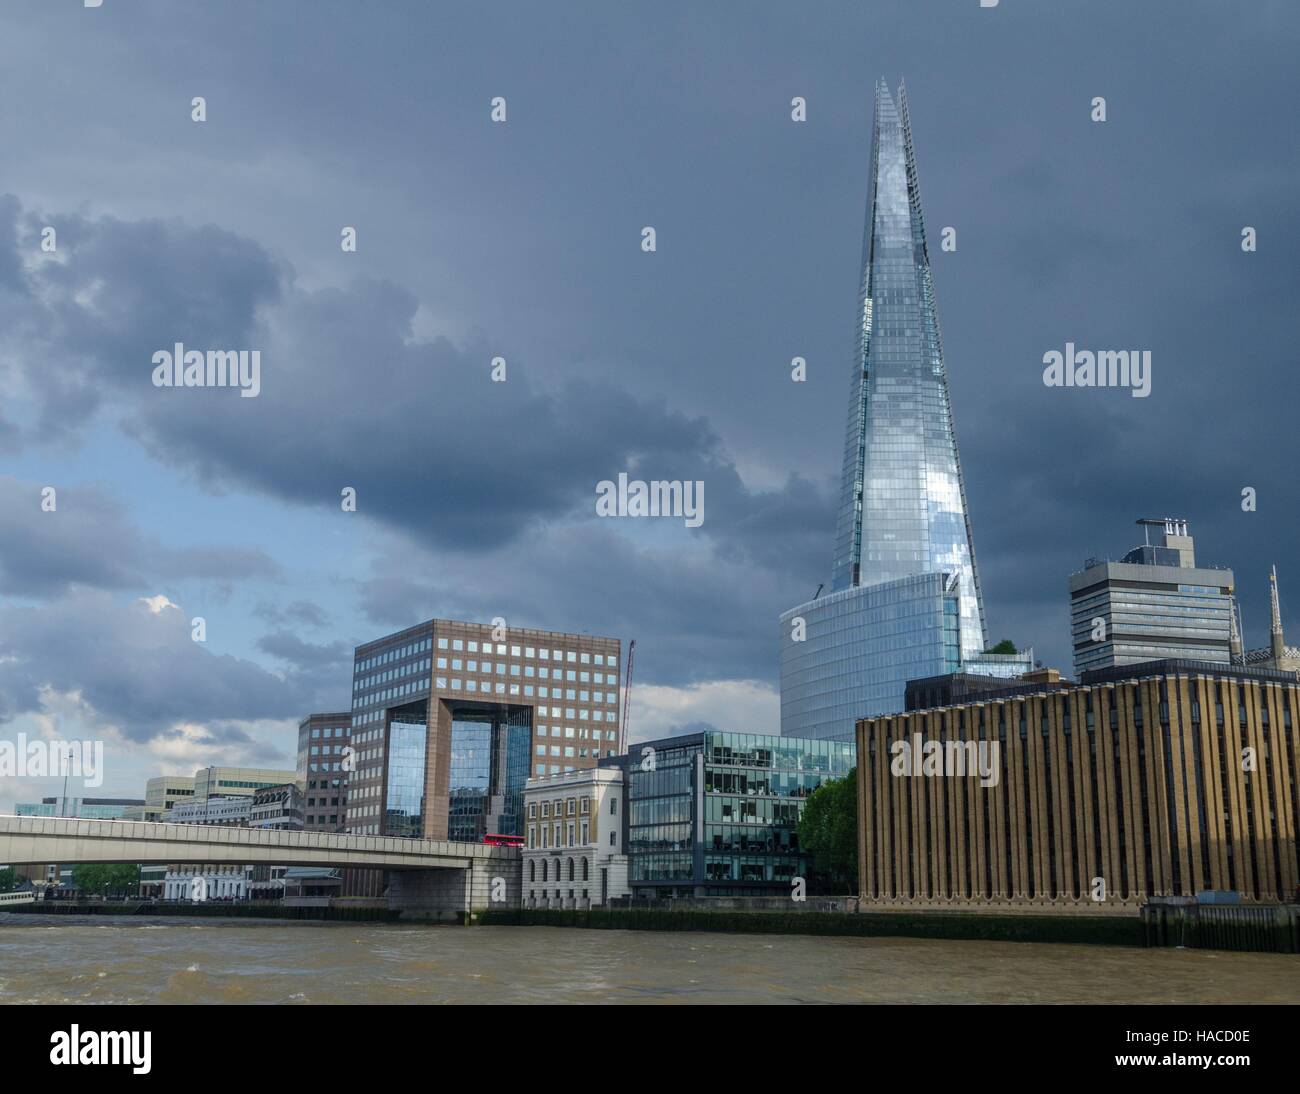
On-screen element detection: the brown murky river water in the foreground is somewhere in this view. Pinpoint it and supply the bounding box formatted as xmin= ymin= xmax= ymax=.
xmin=0 ymin=915 xmax=1300 ymax=1004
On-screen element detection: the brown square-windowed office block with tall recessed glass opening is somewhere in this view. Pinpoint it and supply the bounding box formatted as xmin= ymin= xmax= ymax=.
xmin=347 ymin=620 xmax=620 ymax=842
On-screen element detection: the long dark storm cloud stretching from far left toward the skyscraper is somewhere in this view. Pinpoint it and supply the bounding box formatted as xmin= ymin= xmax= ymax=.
xmin=0 ymin=200 xmax=829 ymax=584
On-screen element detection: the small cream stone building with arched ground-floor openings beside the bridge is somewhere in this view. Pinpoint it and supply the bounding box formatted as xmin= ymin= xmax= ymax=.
xmin=523 ymin=761 xmax=629 ymax=908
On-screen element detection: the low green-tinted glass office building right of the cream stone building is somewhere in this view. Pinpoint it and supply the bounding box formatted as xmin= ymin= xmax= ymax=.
xmin=618 ymin=730 xmax=854 ymax=899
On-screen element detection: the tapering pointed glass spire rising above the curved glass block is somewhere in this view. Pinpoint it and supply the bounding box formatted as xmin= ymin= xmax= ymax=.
xmin=831 ymin=83 xmax=985 ymax=654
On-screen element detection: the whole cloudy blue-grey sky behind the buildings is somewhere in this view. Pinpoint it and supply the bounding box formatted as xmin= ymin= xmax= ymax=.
xmin=0 ymin=0 xmax=1300 ymax=808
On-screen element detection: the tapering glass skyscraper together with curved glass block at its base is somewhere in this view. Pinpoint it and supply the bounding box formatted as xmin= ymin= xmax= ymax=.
xmin=781 ymin=81 xmax=1008 ymax=738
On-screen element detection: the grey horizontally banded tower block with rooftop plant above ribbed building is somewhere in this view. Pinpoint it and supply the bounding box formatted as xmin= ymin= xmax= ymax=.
xmin=1070 ymin=517 xmax=1235 ymax=676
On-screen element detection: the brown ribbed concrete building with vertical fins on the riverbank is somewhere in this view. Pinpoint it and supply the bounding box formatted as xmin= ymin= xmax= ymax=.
xmin=857 ymin=660 xmax=1300 ymax=912
